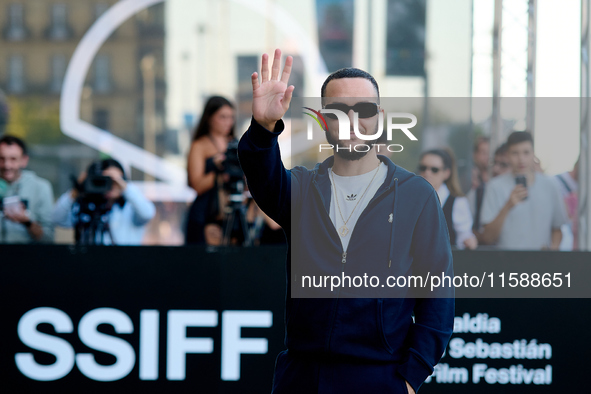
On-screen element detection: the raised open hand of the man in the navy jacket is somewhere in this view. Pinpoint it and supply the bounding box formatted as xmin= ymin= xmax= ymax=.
xmin=252 ymin=49 xmax=294 ymax=131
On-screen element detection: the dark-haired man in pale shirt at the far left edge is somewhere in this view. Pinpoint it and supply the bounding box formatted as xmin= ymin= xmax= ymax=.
xmin=0 ymin=136 xmax=53 ymax=243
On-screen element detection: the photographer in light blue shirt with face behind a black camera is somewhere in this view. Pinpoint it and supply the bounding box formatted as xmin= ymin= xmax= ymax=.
xmin=52 ymin=159 xmax=156 ymax=245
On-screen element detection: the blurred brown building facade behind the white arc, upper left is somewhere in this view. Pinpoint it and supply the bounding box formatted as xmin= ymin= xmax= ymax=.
xmin=0 ymin=0 xmax=166 ymax=151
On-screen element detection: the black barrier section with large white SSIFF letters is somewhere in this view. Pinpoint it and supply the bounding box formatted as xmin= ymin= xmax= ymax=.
xmin=0 ymin=246 xmax=286 ymax=393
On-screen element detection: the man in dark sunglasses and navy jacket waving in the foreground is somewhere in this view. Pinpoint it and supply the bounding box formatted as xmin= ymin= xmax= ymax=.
xmin=239 ymin=50 xmax=454 ymax=394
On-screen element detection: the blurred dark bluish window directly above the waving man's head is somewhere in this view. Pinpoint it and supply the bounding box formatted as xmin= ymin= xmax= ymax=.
xmin=316 ymin=0 xmax=354 ymax=72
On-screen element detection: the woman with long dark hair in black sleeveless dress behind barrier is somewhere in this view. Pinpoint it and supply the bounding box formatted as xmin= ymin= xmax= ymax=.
xmin=185 ymin=96 xmax=235 ymax=245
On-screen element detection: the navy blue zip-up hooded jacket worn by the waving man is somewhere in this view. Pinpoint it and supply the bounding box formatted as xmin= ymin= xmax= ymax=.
xmin=238 ymin=119 xmax=454 ymax=391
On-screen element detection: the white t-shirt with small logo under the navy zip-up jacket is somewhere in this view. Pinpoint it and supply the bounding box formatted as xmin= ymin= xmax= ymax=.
xmin=328 ymin=163 xmax=388 ymax=251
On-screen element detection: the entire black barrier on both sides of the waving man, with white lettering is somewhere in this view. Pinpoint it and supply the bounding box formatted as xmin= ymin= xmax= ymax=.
xmin=0 ymin=246 xmax=591 ymax=393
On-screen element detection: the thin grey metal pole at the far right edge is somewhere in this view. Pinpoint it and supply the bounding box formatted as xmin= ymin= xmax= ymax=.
xmin=577 ymin=0 xmax=591 ymax=251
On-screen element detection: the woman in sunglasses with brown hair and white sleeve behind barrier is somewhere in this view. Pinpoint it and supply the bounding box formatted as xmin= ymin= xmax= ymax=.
xmin=419 ymin=149 xmax=478 ymax=249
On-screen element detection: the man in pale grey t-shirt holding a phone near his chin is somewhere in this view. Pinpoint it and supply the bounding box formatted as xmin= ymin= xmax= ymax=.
xmin=481 ymin=132 xmax=568 ymax=250
